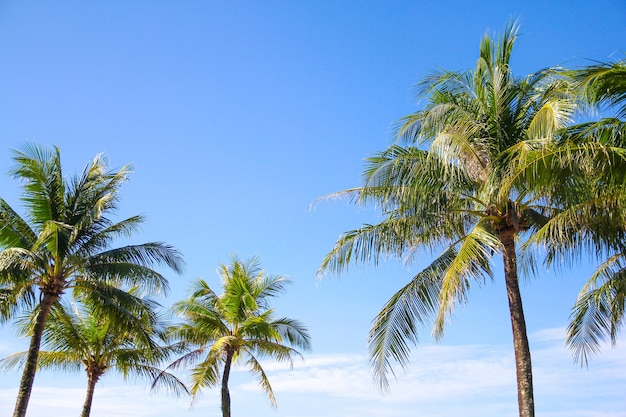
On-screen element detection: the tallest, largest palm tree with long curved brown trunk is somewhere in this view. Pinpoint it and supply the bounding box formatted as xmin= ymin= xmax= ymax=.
xmin=319 ymin=22 xmax=576 ymax=417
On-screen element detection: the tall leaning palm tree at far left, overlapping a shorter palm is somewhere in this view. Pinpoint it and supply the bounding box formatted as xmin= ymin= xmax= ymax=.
xmin=0 ymin=145 xmax=183 ymax=417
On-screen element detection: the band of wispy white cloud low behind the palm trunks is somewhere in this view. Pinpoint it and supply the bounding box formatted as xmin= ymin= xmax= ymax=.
xmin=0 ymin=329 xmax=626 ymax=417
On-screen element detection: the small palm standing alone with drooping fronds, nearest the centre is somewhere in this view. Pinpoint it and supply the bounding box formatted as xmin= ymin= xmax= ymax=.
xmin=158 ymin=257 xmax=310 ymax=417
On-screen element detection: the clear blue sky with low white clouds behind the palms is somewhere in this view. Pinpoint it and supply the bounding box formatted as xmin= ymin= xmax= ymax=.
xmin=0 ymin=0 xmax=626 ymax=417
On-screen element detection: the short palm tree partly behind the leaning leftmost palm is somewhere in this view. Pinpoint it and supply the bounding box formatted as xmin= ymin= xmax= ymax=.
xmin=0 ymin=300 xmax=186 ymax=417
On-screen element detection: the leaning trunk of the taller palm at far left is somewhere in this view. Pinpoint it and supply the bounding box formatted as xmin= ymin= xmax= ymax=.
xmin=13 ymin=294 xmax=59 ymax=417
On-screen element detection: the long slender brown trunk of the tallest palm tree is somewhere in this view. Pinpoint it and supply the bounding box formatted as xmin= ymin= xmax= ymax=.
xmin=499 ymin=228 xmax=535 ymax=417
